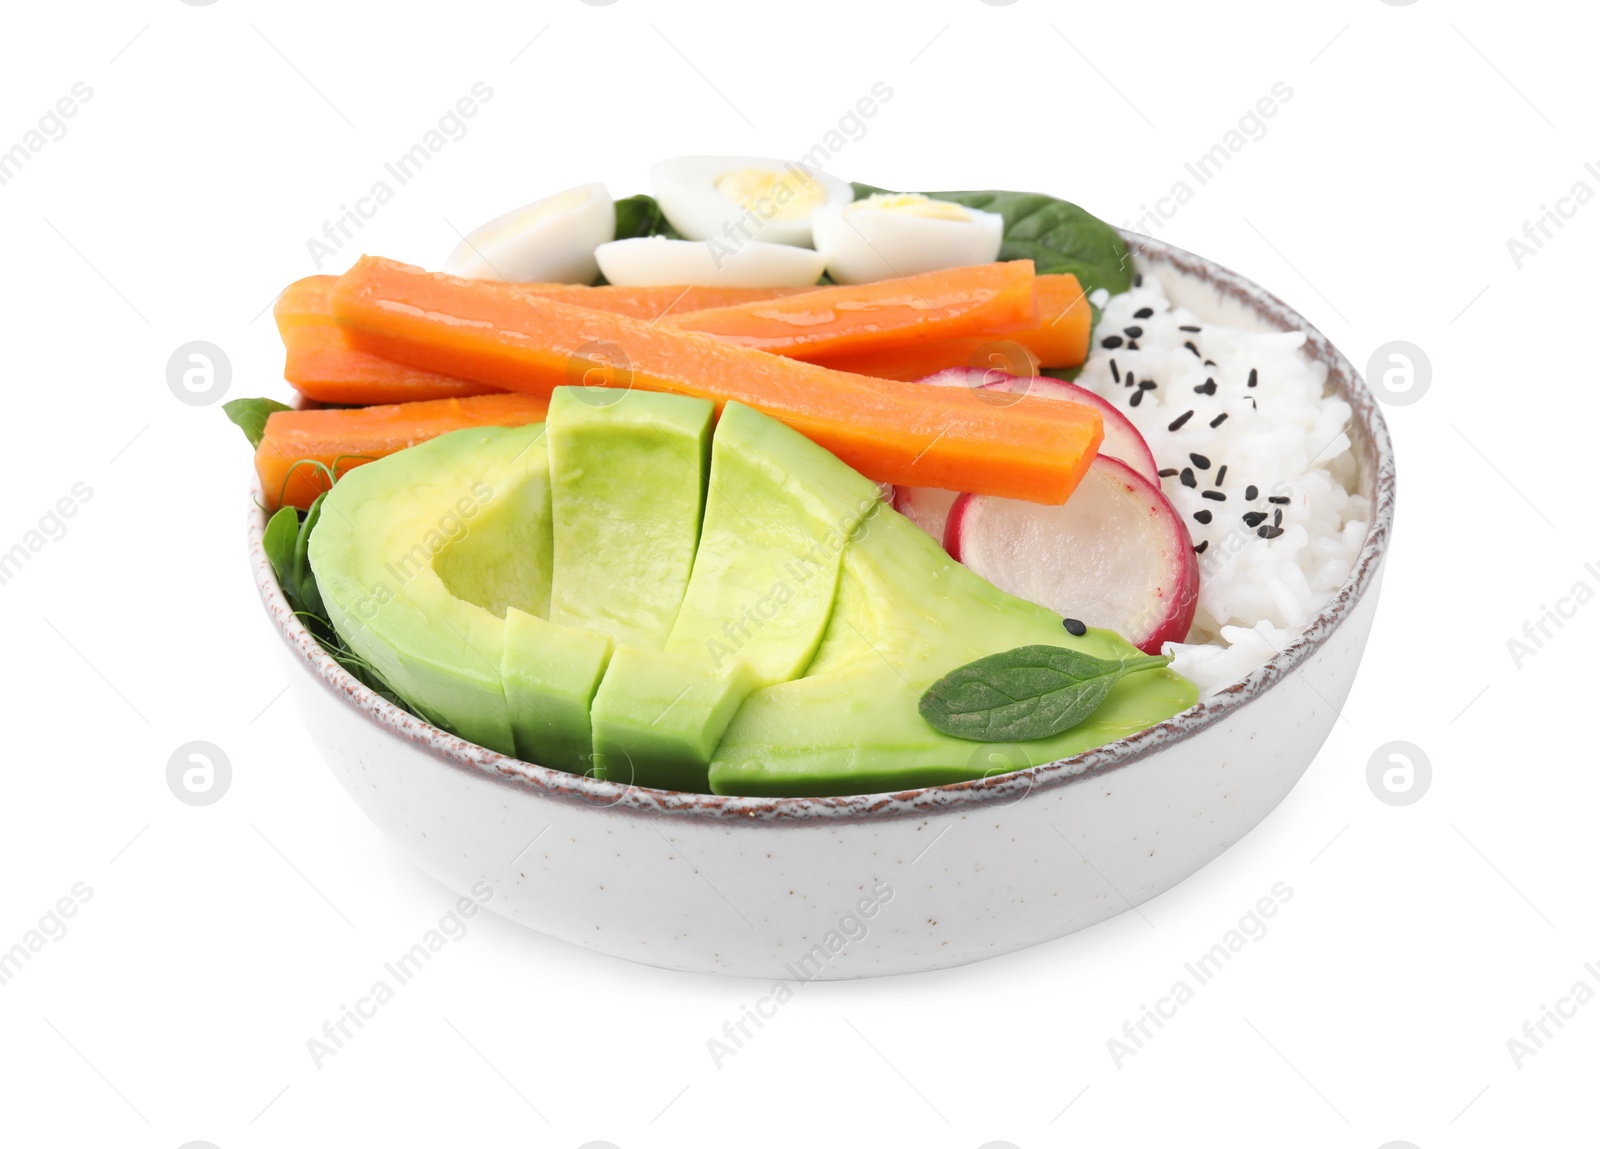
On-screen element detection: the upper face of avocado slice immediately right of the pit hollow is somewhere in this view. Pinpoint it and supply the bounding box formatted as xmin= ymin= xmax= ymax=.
xmin=549 ymin=387 xmax=715 ymax=650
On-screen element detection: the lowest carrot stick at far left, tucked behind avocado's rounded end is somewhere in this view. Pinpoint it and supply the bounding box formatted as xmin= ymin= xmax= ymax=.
xmin=256 ymin=394 xmax=549 ymax=510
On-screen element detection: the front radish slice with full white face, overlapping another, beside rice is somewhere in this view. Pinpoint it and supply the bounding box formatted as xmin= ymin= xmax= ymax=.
xmin=944 ymin=454 xmax=1200 ymax=655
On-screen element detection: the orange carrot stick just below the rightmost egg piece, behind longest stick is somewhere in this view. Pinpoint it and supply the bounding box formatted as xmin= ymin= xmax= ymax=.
xmin=664 ymin=259 xmax=1038 ymax=362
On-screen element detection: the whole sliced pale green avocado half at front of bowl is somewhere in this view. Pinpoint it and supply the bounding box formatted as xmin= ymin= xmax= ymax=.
xmin=310 ymin=387 xmax=1195 ymax=795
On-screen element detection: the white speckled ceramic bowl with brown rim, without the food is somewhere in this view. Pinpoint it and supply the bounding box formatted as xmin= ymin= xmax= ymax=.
xmin=250 ymin=237 xmax=1395 ymax=981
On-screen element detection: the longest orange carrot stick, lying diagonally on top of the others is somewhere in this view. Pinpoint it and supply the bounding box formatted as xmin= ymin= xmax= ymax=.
xmin=324 ymin=256 xmax=1102 ymax=502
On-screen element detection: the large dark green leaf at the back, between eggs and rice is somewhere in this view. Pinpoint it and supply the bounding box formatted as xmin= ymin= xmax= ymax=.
xmin=853 ymin=184 xmax=1133 ymax=294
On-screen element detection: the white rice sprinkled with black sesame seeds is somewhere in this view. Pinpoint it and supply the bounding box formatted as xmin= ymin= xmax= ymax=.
xmin=1078 ymin=275 xmax=1371 ymax=698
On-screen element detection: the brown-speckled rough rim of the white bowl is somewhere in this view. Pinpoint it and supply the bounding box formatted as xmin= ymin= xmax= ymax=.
xmin=248 ymin=230 xmax=1395 ymax=826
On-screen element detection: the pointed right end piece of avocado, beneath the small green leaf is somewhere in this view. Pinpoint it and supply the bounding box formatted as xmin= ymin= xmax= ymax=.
xmin=709 ymin=507 xmax=1197 ymax=795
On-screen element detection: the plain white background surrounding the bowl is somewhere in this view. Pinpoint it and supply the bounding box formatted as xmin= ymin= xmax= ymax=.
xmin=0 ymin=0 xmax=1600 ymax=1149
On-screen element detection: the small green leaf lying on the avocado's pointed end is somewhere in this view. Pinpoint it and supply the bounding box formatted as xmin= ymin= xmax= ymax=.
xmin=917 ymin=647 xmax=1171 ymax=743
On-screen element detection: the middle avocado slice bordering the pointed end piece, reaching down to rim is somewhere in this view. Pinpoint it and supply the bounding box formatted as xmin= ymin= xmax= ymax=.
xmin=592 ymin=403 xmax=882 ymax=791
